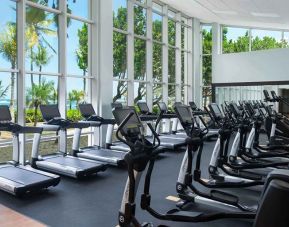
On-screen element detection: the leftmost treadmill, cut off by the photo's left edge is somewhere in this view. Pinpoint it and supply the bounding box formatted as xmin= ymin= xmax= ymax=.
xmin=0 ymin=106 xmax=60 ymax=196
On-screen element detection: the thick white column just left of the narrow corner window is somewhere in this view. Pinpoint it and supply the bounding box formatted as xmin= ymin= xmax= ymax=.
xmin=192 ymin=18 xmax=202 ymax=106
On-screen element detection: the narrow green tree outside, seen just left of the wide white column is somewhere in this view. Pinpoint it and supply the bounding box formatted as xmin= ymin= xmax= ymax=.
xmin=76 ymin=23 xmax=88 ymax=91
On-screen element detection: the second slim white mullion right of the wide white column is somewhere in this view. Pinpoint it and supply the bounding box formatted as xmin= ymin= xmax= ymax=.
xmin=146 ymin=0 xmax=153 ymax=110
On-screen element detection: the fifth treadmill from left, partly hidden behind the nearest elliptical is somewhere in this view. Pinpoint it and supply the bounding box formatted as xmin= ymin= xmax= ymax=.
xmin=137 ymin=102 xmax=186 ymax=150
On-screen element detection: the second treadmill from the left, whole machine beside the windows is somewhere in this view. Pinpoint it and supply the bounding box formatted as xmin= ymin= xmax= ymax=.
xmin=32 ymin=105 xmax=107 ymax=179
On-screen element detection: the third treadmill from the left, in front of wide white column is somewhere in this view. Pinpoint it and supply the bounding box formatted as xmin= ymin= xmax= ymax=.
xmin=73 ymin=104 xmax=126 ymax=166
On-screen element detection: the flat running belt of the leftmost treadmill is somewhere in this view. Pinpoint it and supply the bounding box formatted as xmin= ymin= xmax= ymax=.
xmin=0 ymin=166 xmax=51 ymax=185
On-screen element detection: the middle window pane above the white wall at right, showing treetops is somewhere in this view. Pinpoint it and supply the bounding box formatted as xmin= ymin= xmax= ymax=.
xmin=252 ymin=29 xmax=282 ymax=51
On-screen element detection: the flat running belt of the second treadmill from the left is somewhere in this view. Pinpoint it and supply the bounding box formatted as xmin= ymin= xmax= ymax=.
xmin=40 ymin=156 xmax=103 ymax=169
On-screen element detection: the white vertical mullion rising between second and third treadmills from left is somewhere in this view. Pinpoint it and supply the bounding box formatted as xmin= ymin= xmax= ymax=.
xmin=58 ymin=1 xmax=67 ymax=117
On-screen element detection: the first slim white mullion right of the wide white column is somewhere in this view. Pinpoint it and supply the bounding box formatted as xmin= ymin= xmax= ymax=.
xmin=127 ymin=0 xmax=134 ymax=105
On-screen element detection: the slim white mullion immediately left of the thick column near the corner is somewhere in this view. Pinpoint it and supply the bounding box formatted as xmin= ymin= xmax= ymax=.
xmin=185 ymin=18 xmax=194 ymax=101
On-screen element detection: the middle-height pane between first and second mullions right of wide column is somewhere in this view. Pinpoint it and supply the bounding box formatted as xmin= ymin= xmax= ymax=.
xmin=134 ymin=38 xmax=146 ymax=80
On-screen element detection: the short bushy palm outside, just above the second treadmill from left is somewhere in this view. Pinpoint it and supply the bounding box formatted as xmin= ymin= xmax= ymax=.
xmin=27 ymin=78 xmax=54 ymax=126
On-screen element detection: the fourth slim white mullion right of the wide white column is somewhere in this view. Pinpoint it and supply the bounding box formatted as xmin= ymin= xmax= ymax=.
xmin=175 ymin=13 xmax=182 ymax=102
